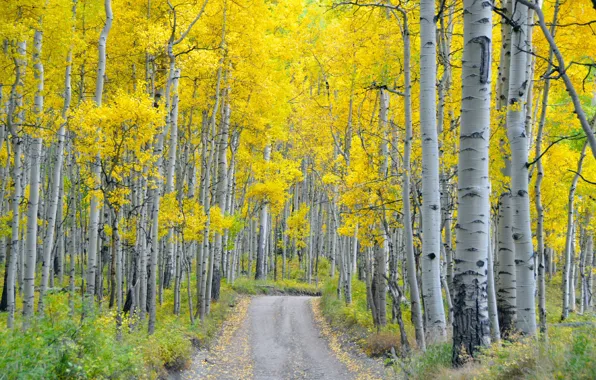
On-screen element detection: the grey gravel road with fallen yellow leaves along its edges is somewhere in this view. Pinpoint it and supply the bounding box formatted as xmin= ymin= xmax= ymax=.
xmin=177 ymin=296 xmax=385 ymax=379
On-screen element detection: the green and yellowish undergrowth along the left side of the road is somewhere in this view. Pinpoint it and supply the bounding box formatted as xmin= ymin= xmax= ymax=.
xmin=0 ymin=283 xmax=238 ymax=379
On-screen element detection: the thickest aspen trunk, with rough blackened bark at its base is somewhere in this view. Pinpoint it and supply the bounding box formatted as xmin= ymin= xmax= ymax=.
xmin=452 ymin=0 xmax=492 ymax=365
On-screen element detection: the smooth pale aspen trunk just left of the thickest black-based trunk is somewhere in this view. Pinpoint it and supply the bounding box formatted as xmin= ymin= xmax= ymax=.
xmin=420 ymin=0 xmax=447 ymax=342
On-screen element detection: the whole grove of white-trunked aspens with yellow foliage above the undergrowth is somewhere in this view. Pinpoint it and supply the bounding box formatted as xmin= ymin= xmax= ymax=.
xmin=0 ymin=0 xmax=596 ymax=378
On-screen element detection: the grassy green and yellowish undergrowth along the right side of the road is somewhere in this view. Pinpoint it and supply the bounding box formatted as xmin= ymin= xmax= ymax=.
xmin=321 ymin=276 xmax=596 ymax=380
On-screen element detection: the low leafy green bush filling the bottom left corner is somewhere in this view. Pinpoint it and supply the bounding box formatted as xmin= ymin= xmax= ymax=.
xmin=0 ymin=310 xmax=143 ymax=379
